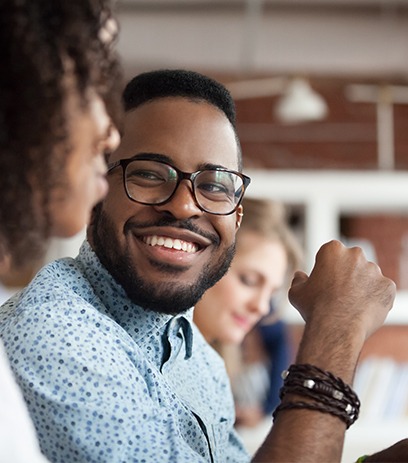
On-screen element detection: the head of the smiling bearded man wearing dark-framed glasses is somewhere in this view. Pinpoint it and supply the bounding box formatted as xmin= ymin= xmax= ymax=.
xmin=88 ymin=80 xmax=245 ymax=314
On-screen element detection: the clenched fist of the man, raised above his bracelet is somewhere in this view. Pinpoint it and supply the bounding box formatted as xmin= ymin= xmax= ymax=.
xmin=289 ymin=241 xmax=396 ymax=339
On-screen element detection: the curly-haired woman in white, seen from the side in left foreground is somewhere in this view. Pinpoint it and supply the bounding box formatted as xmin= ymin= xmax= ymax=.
xmin=0 ymin=0 xmax=122 ymax=463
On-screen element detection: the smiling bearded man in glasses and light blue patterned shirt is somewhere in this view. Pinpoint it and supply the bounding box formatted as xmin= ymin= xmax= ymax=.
xmin=1 ymin=71 xmax=402 ymax=463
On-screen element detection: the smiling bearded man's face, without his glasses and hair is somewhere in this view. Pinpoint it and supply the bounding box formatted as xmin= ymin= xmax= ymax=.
xmin=88 ymin=98 xmax=240 ymax=313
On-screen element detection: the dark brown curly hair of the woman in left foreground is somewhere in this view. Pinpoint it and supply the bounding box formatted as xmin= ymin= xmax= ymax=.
xmin=0 ymin=0 xmax=122 ymax=266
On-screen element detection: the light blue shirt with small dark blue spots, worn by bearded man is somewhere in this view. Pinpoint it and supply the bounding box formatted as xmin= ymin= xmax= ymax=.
xmin=0 ymin=242 xmax=249 ymax=463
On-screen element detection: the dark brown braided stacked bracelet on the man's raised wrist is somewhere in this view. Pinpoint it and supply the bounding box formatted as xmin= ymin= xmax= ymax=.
xmin=273 ymin=364 xmax=360 ymax=428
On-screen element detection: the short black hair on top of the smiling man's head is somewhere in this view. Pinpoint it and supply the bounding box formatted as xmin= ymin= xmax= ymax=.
xmin=123 ymin=69 xmax=242 ymax=170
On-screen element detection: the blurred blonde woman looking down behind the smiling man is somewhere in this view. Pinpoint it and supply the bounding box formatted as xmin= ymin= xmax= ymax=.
xmin=194 ymin=198 xmax=302 ymax=432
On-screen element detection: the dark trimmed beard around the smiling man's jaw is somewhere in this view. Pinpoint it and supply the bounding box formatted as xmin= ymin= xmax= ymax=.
xmin=90 ymin=203 xmax=235 ymax=315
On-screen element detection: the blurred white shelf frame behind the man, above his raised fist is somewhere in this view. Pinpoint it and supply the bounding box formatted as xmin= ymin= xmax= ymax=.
xmin=245 ymin=169 xmax=408 ymax=270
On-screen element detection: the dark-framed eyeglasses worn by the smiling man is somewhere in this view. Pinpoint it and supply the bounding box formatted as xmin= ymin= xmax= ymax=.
xmin=108 ymin=158 xmax=251 ymax=215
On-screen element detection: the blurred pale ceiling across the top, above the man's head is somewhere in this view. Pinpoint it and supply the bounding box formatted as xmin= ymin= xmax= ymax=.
xmin=118 ymin=0 xmax=408 ymax=79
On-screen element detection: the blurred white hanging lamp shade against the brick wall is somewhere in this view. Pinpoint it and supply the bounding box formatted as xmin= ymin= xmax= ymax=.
xmin=274 ymin=77 xmax=328 ymax=124
